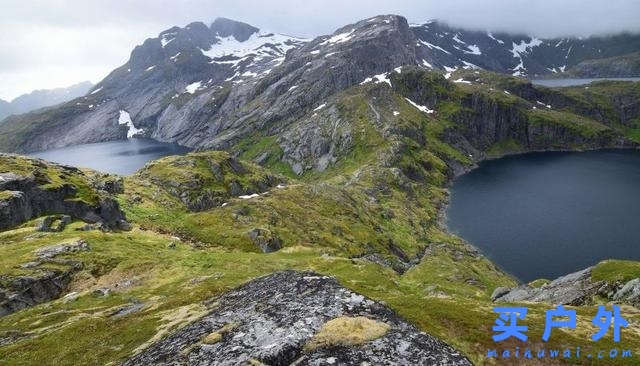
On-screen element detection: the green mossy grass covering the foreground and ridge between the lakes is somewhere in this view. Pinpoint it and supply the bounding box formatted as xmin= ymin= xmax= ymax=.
xmin=0 ymin=71 xmax=640 ymax=365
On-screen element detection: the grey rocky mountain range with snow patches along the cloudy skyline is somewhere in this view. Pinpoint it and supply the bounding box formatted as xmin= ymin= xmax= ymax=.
xmin=0 ymin=15 xmax=640 ymax=152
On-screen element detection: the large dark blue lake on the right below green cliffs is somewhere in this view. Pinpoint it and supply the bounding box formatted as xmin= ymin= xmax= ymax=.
xmin=448 ymin=150 xmax=640 ymax=282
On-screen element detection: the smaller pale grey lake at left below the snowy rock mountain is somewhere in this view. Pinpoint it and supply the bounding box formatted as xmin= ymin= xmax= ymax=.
xmin=30 ymin=138 xmax=190 ymax=175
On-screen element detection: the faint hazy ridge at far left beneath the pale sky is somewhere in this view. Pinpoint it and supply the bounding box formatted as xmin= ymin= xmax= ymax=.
xmin=0 ymin=81 xmax=93 ymax=120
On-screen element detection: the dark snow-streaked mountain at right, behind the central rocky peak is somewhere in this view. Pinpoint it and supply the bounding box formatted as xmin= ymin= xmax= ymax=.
xmin=411 ymin=21 xmax=640 ymax=78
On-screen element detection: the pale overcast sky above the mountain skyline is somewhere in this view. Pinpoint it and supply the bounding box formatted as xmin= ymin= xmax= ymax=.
xmin=0 ymin=0 xmax=640 ymax=100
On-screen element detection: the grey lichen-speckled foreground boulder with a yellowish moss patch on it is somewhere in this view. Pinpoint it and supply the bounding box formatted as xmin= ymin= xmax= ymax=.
xmin=124 ymin=271 xmax=471 ymax=366
